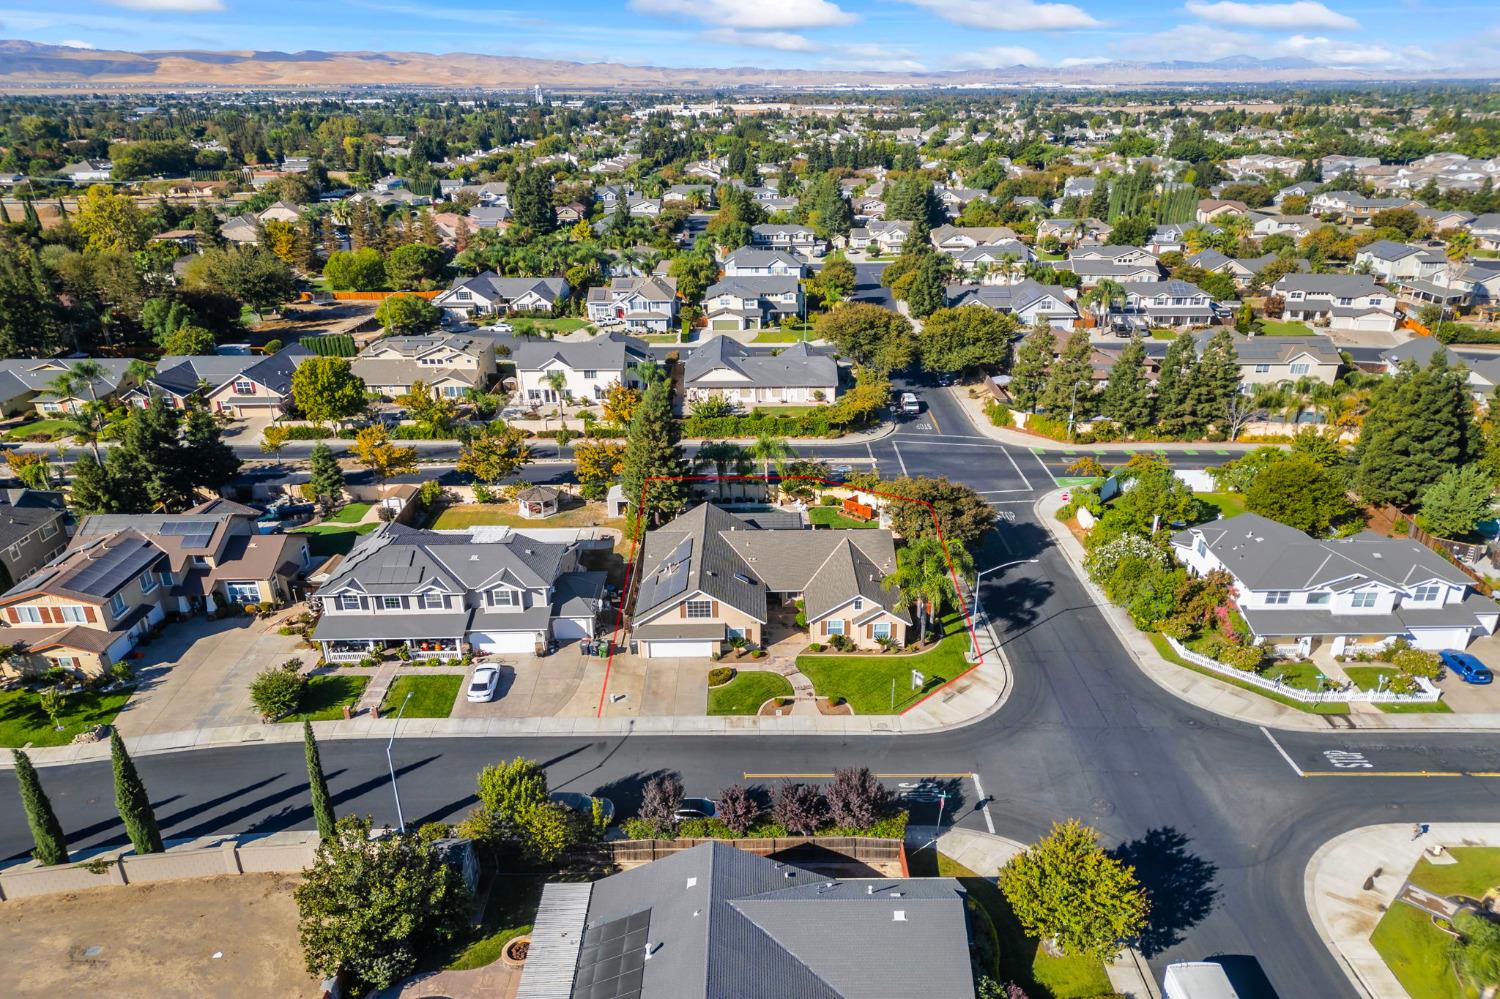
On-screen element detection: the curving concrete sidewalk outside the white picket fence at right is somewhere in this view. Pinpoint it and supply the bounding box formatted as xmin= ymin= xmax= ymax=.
xmin=1034 ymin=489 xmax=1500 ymax=732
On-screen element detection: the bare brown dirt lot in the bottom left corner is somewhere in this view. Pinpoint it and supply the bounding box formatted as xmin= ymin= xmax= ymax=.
xmin=0 ymin=875 xmax=318 ymax=999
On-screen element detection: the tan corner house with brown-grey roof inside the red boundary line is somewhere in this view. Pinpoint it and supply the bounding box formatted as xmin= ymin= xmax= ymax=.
xmin=630 ymin=503 xmax=912 ymax=659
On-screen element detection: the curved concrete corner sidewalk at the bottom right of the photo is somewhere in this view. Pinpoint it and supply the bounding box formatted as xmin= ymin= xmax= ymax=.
xmin=1302 ymin=822 xmax=1500 ymax=999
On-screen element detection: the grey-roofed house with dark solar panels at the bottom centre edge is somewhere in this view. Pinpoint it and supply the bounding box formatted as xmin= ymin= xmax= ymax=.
xmin=516 ymin=843 xmax=974 ymax=999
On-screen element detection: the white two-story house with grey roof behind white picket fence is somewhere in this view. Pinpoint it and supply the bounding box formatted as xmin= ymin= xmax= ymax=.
xmin=1172 ymin=513 xmax=1500 ymax=656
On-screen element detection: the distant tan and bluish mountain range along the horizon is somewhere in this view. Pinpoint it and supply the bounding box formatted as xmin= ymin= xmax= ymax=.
xmin=0 ymin=41 xmax=1500 ymax=92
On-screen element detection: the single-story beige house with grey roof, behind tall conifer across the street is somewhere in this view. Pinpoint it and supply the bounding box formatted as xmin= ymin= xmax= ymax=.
xmin=683 ymin=336 xmax=839 ymax=410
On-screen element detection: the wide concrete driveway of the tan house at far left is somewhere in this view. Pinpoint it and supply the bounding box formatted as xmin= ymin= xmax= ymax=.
xmin=114 ymin=617 xmax=317 ymax=738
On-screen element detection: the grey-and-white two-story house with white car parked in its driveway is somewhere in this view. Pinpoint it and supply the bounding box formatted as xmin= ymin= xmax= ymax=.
xmin=312 ymin=524 xmax=609 ymax=663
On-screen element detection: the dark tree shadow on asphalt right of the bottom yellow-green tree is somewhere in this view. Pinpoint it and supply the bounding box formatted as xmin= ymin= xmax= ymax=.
xmin=1110 ymin=827 xmax=1220 ymax=959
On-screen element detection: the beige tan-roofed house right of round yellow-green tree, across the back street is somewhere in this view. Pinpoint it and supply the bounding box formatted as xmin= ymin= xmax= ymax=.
xmin=350 ymin=333 xmax=495 ymax=399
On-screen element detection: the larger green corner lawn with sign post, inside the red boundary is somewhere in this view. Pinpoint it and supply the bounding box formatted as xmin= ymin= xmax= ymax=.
xmin=797 ymin=614 xmax=971 ymax=714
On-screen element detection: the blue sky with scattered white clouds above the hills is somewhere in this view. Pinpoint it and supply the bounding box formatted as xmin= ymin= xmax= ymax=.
xmin=0 ymin=0 xmax=1500 ymax=75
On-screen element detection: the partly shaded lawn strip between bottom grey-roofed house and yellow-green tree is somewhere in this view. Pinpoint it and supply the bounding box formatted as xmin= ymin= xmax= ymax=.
xmin=911 ymin=849 xmax=1112 ymax=999
